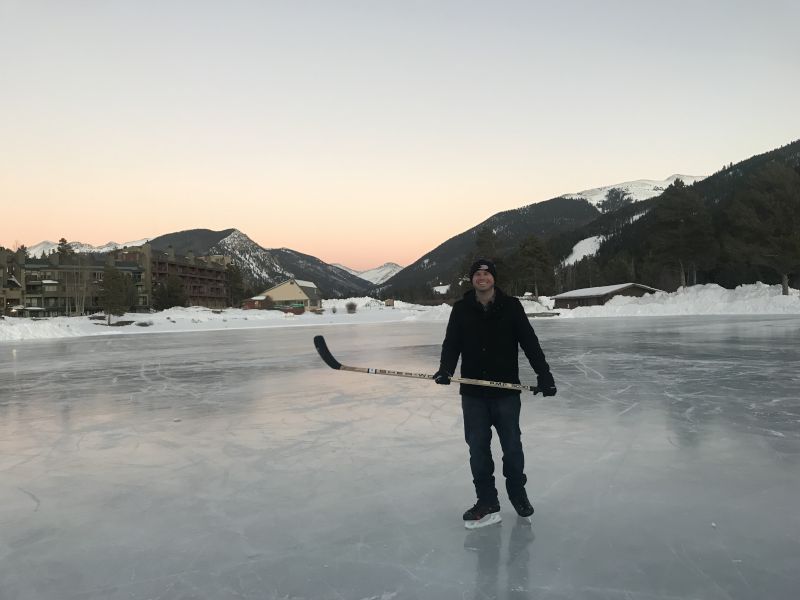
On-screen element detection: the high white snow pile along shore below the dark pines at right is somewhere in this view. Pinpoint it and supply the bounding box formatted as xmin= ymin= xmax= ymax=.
xmin=558 ymin=283 xmax=800 ymax=317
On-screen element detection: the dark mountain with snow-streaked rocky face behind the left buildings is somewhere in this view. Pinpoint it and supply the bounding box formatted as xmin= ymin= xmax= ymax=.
xmin=150 ymin=229 xmax=371 ymax=298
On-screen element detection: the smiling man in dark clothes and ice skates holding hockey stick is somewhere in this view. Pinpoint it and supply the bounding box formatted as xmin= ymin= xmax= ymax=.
xmin=433 ymin=258 xmax=556 ymax=529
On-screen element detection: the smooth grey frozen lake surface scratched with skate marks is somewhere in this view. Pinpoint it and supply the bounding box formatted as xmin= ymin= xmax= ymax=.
xmin=0 ymin=316 xmax=800 ymax=600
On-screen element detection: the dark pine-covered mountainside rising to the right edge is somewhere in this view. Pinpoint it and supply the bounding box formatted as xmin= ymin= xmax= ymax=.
xmin=548 ymin=140 xmax=800 ymax=290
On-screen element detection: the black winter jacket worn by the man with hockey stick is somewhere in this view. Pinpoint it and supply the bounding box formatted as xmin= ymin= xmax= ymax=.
xmin=439 ymin=287 xmax=553 ymax=398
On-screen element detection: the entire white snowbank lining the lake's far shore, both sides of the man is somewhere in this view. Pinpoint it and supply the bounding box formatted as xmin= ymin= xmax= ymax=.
xmin=0 ymin=283 xmax=800 ymax=343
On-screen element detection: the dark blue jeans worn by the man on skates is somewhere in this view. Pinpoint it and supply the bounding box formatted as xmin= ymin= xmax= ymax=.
xmin=461 ymin=394 xmax=528 ymax=504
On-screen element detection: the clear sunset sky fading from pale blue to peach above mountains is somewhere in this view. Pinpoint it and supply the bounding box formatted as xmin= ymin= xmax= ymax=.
xmin=0 ymin=0 xmax=800 ymax=269
